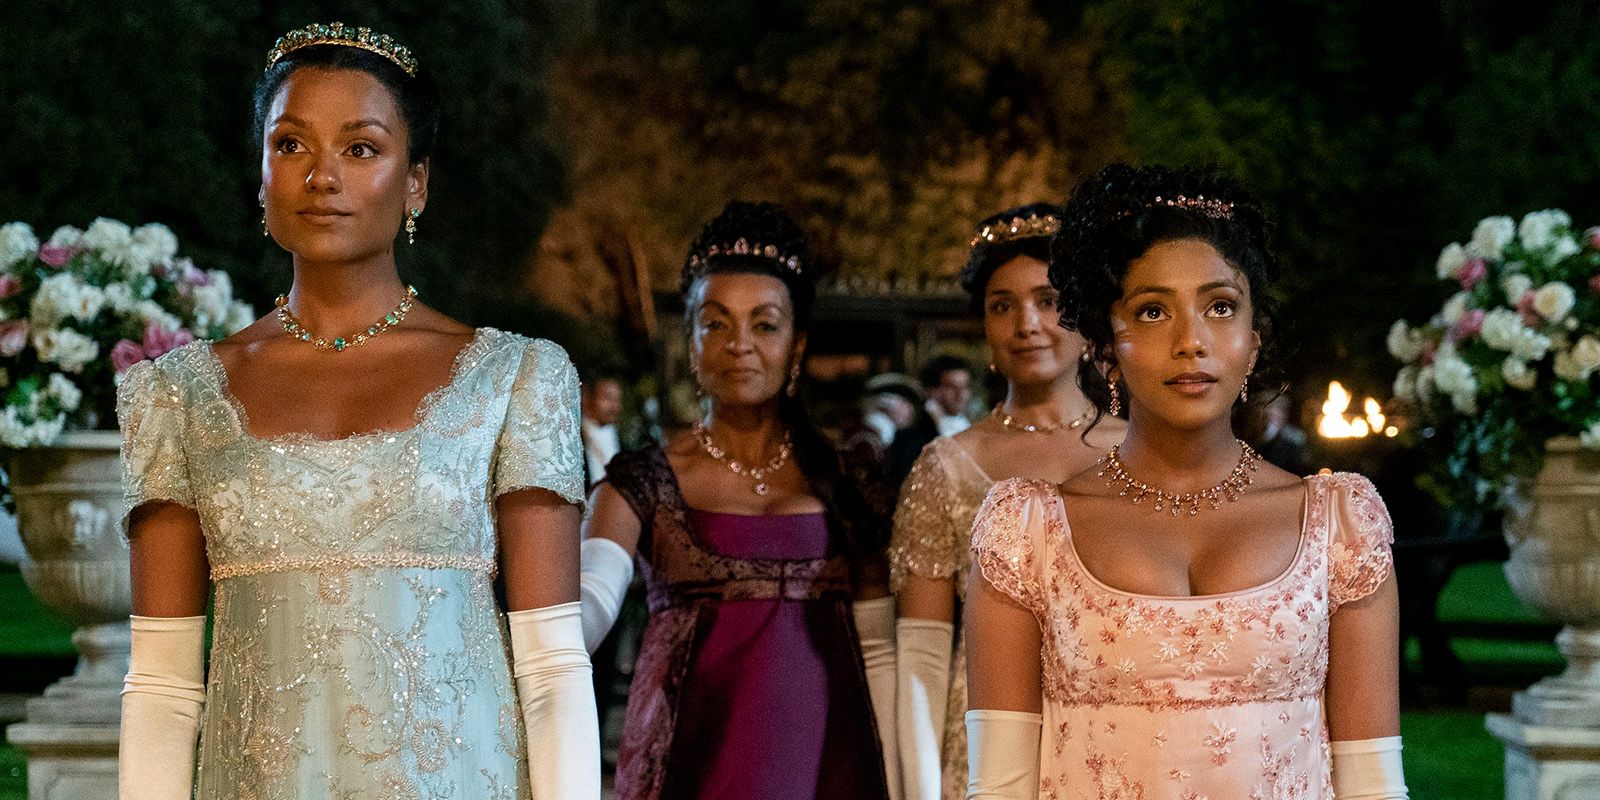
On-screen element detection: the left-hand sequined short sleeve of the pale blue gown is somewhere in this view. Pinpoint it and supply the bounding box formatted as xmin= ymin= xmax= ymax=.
xmin=117 ymin=362 xmax=195 ymax=515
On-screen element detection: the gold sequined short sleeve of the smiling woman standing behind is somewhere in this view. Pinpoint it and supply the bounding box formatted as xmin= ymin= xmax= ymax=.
xmin=890 ymin=440 xmax=966 ymax=592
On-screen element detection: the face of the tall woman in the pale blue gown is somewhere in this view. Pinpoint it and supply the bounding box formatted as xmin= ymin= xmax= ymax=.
xmin=261 ymin=67 xmax=427 ymax=261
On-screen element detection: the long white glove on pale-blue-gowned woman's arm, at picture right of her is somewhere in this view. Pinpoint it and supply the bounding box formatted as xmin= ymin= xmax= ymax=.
xmin=506 ymin=603 xmax=600 ymax=800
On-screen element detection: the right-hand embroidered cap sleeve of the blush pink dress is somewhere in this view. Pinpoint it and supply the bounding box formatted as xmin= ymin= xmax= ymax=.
xmin=1328 ymin=474 xmax=1395 ymax=611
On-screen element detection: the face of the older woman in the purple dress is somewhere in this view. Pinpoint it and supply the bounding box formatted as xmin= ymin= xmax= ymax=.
xmin=690 ymin=272 xmax=805 ymax=405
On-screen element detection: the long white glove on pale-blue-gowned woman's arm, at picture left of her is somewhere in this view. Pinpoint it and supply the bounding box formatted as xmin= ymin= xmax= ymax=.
xmin=117 ymin=616 xmax=205 ymax=800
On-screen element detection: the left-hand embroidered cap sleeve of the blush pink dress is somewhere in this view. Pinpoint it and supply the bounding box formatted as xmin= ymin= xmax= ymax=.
xmin=973 ymin=478 xmax=1061 ymax=618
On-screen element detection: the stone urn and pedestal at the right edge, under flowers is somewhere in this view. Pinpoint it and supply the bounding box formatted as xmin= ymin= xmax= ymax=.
xmin=1488 ymin=437 xmax=1600 ymax=800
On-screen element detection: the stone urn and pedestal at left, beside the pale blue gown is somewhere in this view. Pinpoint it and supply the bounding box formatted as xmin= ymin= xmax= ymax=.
xmin=6 ymin=430 xmax=131 ymax=800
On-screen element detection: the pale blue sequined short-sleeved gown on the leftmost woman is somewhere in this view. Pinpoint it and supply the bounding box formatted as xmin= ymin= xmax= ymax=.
xmin=118 ymin=328 xmax=582 ymax=798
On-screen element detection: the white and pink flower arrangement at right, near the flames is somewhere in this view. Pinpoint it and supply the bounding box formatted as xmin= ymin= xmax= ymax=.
xmin=1387 ymin=210 xmax=1600 ymax=504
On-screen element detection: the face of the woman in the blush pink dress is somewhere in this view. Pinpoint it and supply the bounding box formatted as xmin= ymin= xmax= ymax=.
xmin=1110 ymin=238 xmax=1261 ymax=429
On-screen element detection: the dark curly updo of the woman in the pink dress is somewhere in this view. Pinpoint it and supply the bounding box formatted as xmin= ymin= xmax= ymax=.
xmin=1050 ymin=163 xmax=1283 ymax=422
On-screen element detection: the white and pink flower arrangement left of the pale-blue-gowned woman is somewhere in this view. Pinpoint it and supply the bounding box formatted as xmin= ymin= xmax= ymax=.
xmin=0 ymin=218 xmax=254 ymax=448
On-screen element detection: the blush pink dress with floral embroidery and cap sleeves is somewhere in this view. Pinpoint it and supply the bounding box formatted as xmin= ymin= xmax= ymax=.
xmin=973 ymin=474 xmax=1394 ymax=800
